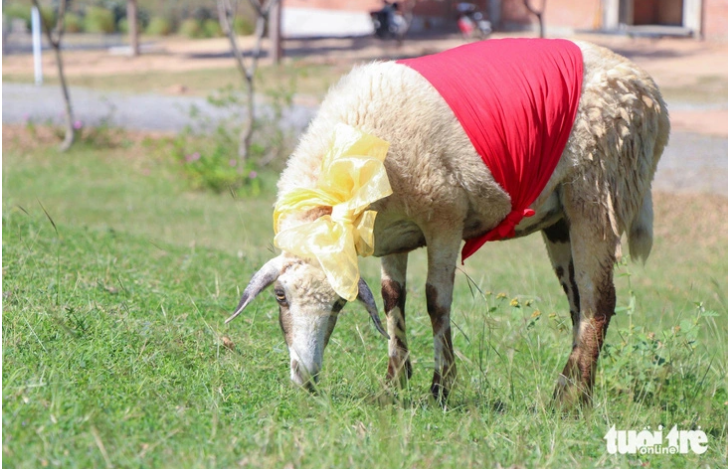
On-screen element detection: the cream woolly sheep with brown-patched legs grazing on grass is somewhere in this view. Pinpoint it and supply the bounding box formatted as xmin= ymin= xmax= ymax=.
xmin=228 ymin=42 xmax=670 ymax=405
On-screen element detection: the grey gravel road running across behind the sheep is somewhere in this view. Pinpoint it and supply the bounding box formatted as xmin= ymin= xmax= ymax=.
xmin=2 ymin=83 xmax=728 ymax=196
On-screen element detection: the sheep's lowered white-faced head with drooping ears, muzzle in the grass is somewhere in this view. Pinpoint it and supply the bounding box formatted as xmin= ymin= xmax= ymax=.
xmin=226 ymin=254 xmax=388 ymax=390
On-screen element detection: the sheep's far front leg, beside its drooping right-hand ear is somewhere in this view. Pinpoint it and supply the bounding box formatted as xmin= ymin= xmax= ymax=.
xmin=382 ymin=253 xmax=412 ymax=382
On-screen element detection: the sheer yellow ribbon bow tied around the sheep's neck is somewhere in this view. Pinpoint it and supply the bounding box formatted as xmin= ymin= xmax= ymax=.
xmin=273 ymin=124 xmax=392 ymax=301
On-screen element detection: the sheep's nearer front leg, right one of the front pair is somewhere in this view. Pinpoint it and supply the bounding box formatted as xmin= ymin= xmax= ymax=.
xmin=425 ymin=232 xmax=462 ymax=402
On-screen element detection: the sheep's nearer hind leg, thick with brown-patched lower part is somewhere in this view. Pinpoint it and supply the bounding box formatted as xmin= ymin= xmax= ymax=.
xmin=554 ymin=207 xmax=619 ymax=407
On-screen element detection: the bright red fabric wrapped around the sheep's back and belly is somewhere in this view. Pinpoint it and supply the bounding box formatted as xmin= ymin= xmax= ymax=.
xmin=398 ymin=39 xmax=584 ymax=261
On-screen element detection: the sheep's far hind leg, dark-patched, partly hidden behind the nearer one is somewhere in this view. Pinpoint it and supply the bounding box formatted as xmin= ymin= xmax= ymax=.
xmin=541 ymin=218 xmax=579 ymax=349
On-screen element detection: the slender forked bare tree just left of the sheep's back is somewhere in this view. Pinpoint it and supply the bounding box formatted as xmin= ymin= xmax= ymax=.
xmin=217 ymin=0 xmax=280 ymax=167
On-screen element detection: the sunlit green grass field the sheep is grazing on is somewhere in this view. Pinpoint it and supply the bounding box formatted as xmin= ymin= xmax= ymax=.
xmin=2 ymin=127 xmax=728 ymax=468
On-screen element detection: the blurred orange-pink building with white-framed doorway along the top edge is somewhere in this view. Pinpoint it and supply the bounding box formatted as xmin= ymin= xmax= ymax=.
xmin=283 ymin=0 xmax=728 ymax=41
